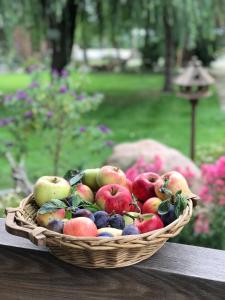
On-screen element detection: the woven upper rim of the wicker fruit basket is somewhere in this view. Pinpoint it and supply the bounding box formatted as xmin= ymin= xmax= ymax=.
xmin=15 ymin=194 xmax=193 ymax=242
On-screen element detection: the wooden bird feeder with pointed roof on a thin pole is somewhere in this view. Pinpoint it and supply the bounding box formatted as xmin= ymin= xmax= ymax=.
xmin=174 ymin=56 xmax=214 ymax=160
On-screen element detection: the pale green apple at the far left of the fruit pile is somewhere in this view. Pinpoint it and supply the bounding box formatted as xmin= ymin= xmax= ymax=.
xmin=34 ymin=176 xmax=71 ymax=207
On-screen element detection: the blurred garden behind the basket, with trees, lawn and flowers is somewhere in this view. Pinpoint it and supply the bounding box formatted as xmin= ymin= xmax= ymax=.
xmin=0 ymin=0 xmax=225 ymax=249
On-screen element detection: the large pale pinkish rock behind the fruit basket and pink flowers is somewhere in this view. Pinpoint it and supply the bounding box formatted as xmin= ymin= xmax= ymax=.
xmin=107 ymin=140 xmax=201 ymax=193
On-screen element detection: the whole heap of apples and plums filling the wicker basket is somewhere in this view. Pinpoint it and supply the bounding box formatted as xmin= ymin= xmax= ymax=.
xmin=33 ymin=166 xmax=196 ymax=238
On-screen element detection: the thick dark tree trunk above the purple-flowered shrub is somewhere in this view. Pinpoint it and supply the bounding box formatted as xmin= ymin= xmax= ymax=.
xmin=49 ymin=0 xmax=78 ymax=72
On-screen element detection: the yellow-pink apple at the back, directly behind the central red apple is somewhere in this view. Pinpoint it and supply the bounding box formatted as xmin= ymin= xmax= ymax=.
xmin=96 ymin=166 xmax=126 ymax=187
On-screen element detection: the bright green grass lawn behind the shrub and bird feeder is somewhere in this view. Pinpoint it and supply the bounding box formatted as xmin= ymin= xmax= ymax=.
xmin=0 ymin=74 xmax=225 ymax=187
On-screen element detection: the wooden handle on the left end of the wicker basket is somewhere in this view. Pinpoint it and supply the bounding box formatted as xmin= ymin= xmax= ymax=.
xmin=5 ymin=208 xmax=46 ymax=246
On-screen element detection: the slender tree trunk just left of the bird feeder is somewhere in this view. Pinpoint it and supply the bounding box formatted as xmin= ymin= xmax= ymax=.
xmin=163 ymin=2 xmax=174 ymax=92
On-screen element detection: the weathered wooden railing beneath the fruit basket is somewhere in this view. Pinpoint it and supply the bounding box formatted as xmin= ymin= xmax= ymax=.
xmin=0 ymin=219 xmax=225 ymax=300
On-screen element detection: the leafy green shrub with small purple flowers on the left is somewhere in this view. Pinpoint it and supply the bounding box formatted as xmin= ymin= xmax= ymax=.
xmin=0 ymin=70 xmax=110 ymax=174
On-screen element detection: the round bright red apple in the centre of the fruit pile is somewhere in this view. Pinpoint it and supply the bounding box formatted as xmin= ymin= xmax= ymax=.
xmin=95 ymin=184 xmax=132 ymax=214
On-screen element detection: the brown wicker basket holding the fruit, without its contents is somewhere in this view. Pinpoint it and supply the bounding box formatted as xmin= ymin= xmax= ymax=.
xmin=5 ymin=195 xmax=192 ymax=268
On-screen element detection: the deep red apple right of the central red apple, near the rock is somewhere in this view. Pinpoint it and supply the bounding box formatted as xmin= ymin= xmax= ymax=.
xmin=132 ymin=172 xmax=160 ymax=202
